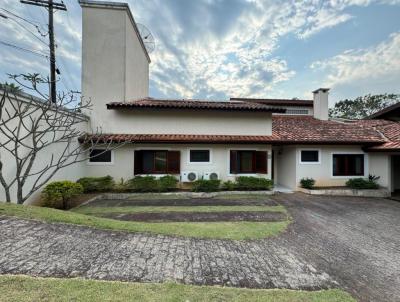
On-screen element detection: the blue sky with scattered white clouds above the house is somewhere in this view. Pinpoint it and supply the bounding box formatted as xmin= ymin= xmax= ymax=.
xmin=0 ymin=0 xmax=400 ymax=106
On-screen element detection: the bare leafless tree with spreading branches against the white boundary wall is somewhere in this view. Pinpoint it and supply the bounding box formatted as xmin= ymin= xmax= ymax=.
xmin=0 ymin=74 xmax=125 ymax=204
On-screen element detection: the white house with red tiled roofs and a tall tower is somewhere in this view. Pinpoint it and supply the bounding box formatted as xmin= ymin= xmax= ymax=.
xmin=0 ymin=0 xmax=400 ymax=203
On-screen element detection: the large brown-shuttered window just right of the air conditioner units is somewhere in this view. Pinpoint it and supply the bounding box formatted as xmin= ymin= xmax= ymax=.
xmin=230 ymin=150 xmax=268 ymax=174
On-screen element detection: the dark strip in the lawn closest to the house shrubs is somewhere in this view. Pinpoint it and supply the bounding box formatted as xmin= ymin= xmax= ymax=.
xmin=90 ymin=198 xmax=278 ymax=207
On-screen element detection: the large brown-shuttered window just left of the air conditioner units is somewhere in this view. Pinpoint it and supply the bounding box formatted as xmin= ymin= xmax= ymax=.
xmin=134 ymin=150 xmax=180 ymax=175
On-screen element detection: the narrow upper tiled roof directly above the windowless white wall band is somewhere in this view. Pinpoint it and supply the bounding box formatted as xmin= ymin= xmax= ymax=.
xmin=107 ymin=98 xmax=286 ymax=113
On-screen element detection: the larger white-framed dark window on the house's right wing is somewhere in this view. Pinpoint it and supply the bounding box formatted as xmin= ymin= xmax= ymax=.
xmin=332 ymin=154 xmax=364 ymax=176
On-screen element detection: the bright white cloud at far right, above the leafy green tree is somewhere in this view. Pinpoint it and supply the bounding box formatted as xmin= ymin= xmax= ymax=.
xmin=310 ymin=32 xmax=400 ymax=88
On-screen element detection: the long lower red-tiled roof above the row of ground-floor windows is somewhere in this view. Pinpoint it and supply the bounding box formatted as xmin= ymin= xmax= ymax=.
xmin=80 ymin=115 xmax=388 ymax=146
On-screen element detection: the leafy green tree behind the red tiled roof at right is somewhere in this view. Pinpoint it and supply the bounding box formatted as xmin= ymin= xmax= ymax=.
xmin=329 ymin=93 xmax=400 ymax=119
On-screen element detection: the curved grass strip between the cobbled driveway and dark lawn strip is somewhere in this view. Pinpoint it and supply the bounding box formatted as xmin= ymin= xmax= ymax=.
xmin=0 ymin=203 xmax=290 ymax=240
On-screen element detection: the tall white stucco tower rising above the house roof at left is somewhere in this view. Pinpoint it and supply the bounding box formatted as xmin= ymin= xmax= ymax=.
xmin=82 ymin=6 xmax=149 ymax=129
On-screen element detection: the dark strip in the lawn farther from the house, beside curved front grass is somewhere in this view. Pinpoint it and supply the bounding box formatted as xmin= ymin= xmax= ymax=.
xmin=102 ymin=211 xmax=287 ymax=222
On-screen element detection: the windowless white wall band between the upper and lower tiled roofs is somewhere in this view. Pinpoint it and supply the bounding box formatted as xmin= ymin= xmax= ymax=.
xmin=101 ymin=109 xmax=272 ymax=135
